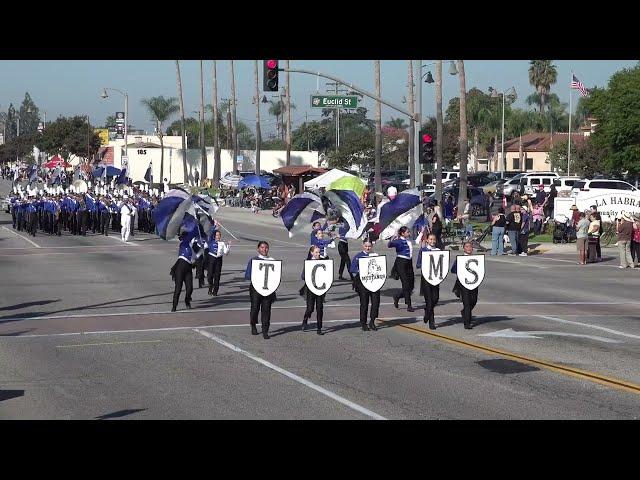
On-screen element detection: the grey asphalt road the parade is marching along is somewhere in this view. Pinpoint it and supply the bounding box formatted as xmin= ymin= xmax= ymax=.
xmin=0 ymin=179 xmax=640 ymax=419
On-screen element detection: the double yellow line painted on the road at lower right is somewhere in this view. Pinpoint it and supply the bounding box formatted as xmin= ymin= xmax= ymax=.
xmin=378 ymin=317 xmax=640 ymax=395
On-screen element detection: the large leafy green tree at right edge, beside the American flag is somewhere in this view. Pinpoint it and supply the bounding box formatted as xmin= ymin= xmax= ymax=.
xmin=584 ymin=63 xmax=640 ymax=176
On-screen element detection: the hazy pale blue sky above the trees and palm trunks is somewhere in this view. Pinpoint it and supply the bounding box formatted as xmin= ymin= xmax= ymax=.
xmin=0 ymin=60 xmax=637 ymax=137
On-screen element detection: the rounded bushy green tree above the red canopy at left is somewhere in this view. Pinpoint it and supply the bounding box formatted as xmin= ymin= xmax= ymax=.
xmin=31 ymin=115 xmax=100 ymax=161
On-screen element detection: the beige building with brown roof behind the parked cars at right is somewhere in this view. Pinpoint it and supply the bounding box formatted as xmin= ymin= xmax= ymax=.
xmin=488 ymin=129 xmax=591 ymax=172
